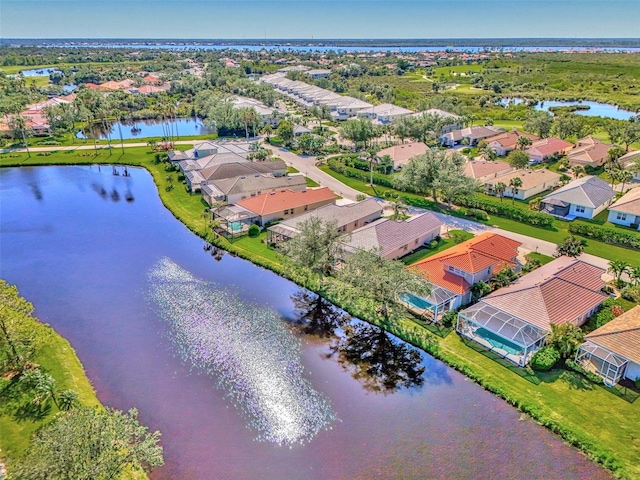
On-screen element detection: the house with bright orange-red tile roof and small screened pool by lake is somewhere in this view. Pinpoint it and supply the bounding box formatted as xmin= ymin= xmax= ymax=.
xmin=405 ymin=233 xmax=522 ymax=321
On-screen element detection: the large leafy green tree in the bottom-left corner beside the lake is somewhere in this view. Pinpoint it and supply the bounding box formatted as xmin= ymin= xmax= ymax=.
xmin=13 ymin=407 xmax=164 ymax=480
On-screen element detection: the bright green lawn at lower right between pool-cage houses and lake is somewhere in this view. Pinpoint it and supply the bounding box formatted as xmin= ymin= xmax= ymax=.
xmin=440 ymin=334 xmax=640 ymax=478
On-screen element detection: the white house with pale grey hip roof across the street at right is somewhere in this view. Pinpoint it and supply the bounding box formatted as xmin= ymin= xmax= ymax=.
xmin=540 ymin=175 xmax=616 ymax=220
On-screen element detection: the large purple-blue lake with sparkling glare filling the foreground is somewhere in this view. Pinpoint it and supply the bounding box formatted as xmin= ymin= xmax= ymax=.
xmin=0 ymin=166 xmax=610 ymax=480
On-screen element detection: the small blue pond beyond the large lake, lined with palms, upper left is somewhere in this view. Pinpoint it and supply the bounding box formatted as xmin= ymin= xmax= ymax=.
xmin=76 ymin=117 xmax=215 ymax=140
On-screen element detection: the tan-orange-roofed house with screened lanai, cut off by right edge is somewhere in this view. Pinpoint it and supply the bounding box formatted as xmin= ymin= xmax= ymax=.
xmin=576 ymin=305 xmax=640 ymax=387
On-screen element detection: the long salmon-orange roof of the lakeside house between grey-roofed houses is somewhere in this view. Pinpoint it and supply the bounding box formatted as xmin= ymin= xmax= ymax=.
xmin=236 ymin=187 xmax=337 ymax=215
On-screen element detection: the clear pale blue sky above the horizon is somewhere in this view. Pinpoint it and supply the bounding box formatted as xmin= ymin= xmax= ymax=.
xmin=0 ymin=0 xmax=640 ymax=39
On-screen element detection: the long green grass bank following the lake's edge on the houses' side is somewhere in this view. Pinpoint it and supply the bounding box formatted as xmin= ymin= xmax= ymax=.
xmin=0 ymin=147 xmax=640 ymax=478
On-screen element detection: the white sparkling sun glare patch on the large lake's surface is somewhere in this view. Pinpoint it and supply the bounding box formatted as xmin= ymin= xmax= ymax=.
xmin=149 ymin=258 xmax=336 ymax=445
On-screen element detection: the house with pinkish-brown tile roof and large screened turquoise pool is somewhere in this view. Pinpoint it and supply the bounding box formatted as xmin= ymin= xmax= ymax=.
xmin=456 ymin=257 xmax=608 ymax=367
